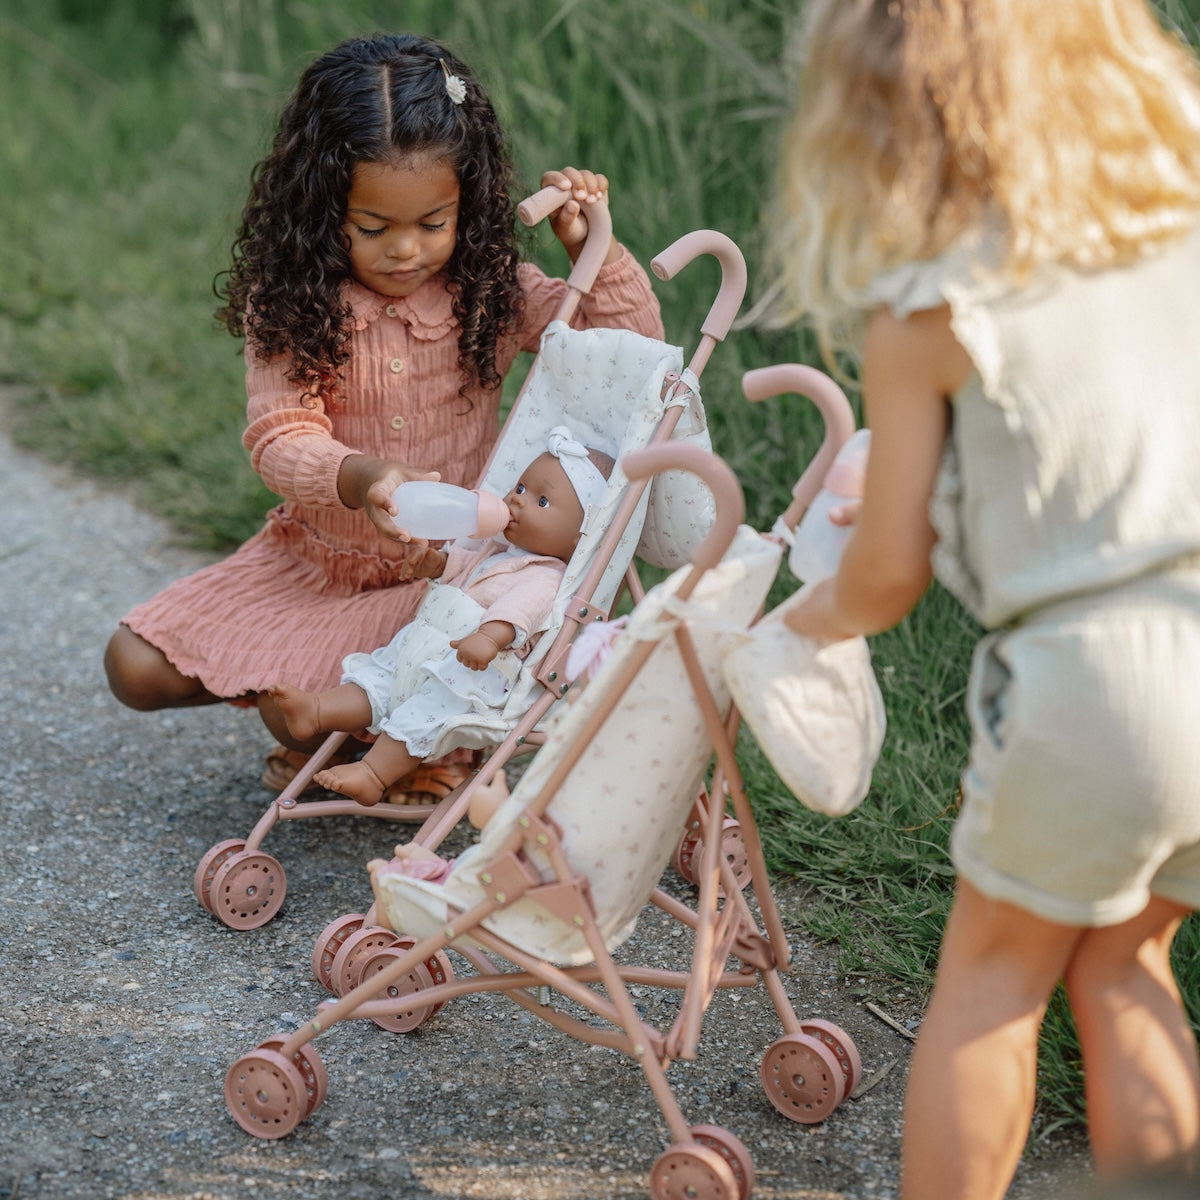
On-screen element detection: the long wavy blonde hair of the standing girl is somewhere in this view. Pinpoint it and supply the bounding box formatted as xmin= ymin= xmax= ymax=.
xmin=760 ymin=0 xmax=1200 ymax=361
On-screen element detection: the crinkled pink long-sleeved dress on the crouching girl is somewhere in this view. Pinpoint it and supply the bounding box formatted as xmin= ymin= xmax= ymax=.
xmin=122 ymin=251 xmax=662 ymax=698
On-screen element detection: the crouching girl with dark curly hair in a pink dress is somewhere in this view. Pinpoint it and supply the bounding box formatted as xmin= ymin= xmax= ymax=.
xmin=104 ymin=35 xmax=662 ymax=793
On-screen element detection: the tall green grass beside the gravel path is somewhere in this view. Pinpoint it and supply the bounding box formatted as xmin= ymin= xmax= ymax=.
xmin=0 ymin=0 xmax=1200 ymax=1128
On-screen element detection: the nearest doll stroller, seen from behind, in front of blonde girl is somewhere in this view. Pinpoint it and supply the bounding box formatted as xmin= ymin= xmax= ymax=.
xmin=226 ymin=444 xmax=862 ymax=1200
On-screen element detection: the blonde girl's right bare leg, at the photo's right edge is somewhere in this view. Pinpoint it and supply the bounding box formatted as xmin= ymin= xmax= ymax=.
xmin=1067 ymin=898 xmax=1200 ymax=1175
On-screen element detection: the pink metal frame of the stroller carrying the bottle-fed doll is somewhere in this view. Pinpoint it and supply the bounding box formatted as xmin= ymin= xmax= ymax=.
xmin=193 ymin=188 xmax=745 ymax=936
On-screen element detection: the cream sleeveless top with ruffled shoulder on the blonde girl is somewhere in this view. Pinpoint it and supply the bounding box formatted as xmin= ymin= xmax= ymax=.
xmin=871 ymin=226 xmax=1200 ymax=628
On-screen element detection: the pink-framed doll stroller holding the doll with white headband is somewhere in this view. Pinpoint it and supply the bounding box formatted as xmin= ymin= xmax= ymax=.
xmin=193 ymin=188 xmax=745 ymax=932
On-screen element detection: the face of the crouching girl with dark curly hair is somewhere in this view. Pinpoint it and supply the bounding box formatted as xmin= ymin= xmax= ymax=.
xmin=342 ymin=155 xmax=458 ymax=296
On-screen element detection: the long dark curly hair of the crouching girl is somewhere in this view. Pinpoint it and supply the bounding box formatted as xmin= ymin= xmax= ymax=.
xmin=215 ymin=34 xmax=523 ymax=400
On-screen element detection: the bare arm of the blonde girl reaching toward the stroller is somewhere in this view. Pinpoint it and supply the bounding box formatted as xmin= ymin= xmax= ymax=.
xmin=786 ymin=307 xmax=971 ymax=640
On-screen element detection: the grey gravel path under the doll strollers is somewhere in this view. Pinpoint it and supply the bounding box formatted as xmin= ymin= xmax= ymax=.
xmin=0 ymin=412 xmax=1099 ymax=1200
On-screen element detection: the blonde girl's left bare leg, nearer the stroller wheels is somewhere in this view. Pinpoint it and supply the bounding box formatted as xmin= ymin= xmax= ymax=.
xmin=901 ymin=881 xmax=1080 ymax=1200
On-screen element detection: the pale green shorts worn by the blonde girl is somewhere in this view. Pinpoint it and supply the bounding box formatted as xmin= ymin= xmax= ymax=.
xmin=952 ymin=571 xmax=1200 ymax=925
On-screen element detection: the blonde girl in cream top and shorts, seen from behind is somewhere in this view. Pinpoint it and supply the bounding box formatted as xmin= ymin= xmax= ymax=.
xmin=773 ymin=0 xmax=1200 ymax=1200
